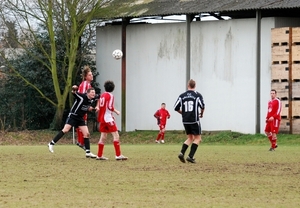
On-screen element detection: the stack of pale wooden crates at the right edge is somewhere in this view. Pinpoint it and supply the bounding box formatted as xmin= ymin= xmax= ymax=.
xmin=271 ymin=27 xmax=300 ymax=134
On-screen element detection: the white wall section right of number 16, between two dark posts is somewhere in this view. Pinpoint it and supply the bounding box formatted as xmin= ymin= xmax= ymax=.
xmin=191 ymin=19 xmax=256 ymax=132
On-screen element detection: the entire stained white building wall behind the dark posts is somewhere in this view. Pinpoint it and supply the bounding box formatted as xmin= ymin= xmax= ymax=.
xmin=97 ymin=18 xmax=300 ymax=133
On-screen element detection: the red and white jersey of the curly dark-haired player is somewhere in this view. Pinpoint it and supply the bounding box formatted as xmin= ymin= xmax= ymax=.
xmin=98 ymin=92 xmax=115 ymax=123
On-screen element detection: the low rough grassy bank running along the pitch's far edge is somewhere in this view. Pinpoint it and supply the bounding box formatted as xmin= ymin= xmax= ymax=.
xmin=0 ymin=130 xmax=300 ymax=145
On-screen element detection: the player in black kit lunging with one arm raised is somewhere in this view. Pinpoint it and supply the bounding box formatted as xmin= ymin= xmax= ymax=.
xmin=48 ymin=85 xmax=99 ymax=158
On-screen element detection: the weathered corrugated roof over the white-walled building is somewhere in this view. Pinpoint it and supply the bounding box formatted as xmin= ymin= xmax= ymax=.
xmin=97 ymin=0 xmax=300 ymax=19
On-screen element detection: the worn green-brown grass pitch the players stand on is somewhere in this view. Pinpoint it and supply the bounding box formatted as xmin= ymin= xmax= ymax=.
xmin=0 ymin=135 xmax=300 ymax=208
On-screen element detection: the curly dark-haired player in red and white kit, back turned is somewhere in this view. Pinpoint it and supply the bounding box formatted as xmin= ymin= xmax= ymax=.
xmin=96 ymin=81 xmax=127 ymax=160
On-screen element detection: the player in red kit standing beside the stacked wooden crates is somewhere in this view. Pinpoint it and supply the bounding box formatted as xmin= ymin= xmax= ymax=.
xmin=265 ymin=89 xmax=281 ymax=151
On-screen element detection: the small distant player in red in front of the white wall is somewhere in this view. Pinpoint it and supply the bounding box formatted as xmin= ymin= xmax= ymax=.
xmin=154 ymin=103 xmax=170 ymax=143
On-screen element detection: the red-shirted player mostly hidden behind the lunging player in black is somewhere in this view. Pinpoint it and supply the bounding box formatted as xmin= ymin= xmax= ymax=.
xmin=76 ymin=66 xmax=93 ymax=149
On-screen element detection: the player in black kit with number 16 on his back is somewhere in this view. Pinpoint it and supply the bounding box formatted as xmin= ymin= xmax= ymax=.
xmin=174 ymin=79 xmax=205 ymax=163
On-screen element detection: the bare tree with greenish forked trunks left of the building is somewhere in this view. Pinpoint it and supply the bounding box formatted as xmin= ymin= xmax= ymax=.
xmin=0 ymin=0 xmax=111 ymax=127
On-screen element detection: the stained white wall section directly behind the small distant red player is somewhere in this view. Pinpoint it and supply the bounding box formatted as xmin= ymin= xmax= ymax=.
xmin=126 ymin=24 xmax=186 ymax=131
